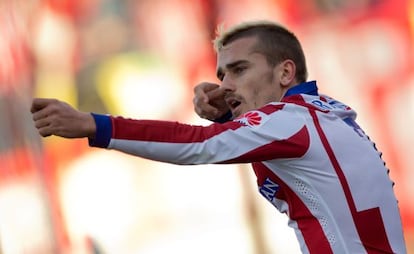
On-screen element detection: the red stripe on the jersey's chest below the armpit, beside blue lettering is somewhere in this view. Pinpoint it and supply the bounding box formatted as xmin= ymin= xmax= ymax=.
xmin=253 ymin=163 xmax=333 ymax=254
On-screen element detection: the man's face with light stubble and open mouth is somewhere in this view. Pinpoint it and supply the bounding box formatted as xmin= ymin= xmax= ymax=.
xmin=217 ymin=37 xmax=285 ymax=117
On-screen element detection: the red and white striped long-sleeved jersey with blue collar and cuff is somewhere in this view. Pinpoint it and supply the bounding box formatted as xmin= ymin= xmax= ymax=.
xmin=89 ymin=81 xmax=406 ymax=254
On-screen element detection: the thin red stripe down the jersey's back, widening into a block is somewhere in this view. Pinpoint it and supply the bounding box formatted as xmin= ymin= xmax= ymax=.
xmin=309 ymin=109 xmax=393 ymax=254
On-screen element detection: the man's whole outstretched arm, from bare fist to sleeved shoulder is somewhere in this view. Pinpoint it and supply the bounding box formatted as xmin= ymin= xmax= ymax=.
xmin=32 ymin=99 xmax=306 ymax=164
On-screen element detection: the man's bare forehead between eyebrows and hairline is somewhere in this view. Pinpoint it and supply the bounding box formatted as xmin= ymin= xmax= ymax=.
xmin=217 ymin=37 xmax=257 ymax=67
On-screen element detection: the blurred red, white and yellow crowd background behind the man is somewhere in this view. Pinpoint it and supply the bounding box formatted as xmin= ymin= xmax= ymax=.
xmin=0 ymin=0 xmax=414 ymax=254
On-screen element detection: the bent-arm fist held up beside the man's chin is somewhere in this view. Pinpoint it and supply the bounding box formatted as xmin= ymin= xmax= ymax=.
xmin=193 ymin=82 xmax=230 ymax=121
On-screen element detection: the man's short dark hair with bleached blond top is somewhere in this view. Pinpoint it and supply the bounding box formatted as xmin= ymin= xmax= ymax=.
xmin=213 ymin=20 xmax=308 ymax=82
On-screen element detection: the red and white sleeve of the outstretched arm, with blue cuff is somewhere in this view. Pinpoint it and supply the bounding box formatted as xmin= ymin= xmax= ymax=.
xmin=90 ymin=105 xmax=309 ymax=164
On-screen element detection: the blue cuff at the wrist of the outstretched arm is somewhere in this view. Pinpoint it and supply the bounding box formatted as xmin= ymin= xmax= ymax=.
xmin=89 ymin=113 xmax=112 ymax=148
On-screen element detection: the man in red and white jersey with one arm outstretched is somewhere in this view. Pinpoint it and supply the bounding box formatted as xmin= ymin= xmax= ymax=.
xmin=31 ymin=22 xmax=406 ymax=254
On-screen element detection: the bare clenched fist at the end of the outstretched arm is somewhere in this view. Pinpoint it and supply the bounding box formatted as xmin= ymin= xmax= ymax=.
xmin=30 ymin=98 xmax=96 ymax=138
